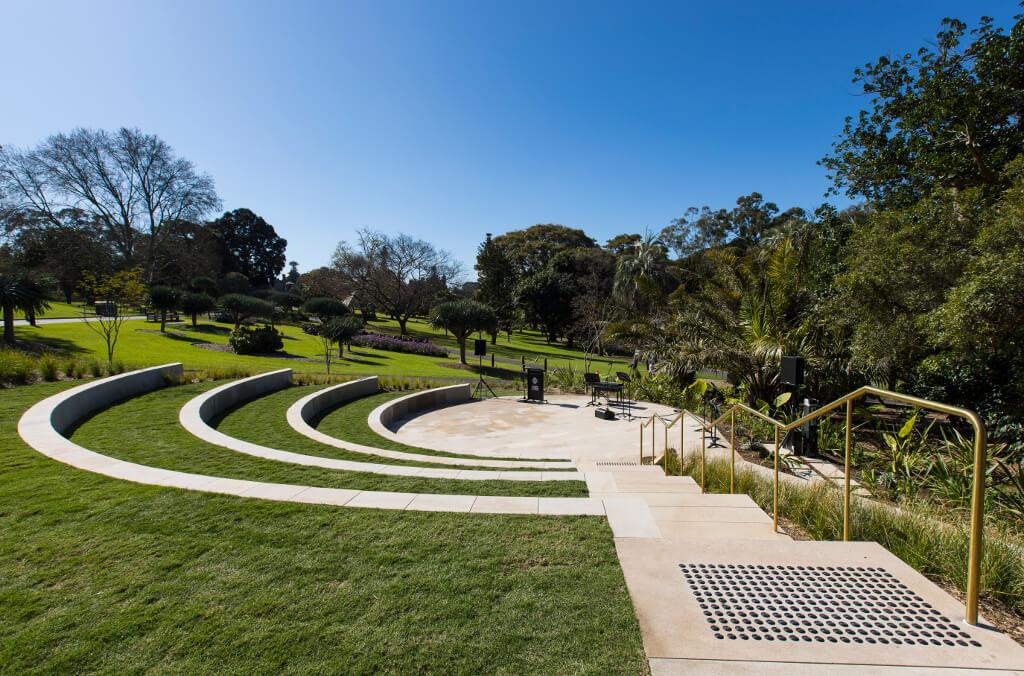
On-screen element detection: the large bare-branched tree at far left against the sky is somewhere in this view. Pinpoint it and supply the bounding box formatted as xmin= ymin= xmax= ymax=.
xmin=0 ymin=128 xmax=220 ymax=279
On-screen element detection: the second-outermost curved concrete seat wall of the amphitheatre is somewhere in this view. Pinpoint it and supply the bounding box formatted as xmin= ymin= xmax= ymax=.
xmin=178 ymin=369 xmax=586 ymax=481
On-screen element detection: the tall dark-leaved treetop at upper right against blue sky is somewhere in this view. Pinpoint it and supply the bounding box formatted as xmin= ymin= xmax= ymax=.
xmin=821 ymin=15 xmax=1024 ymax=207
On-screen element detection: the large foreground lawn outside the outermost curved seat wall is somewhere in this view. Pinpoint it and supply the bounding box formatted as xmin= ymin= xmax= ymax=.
xmin=0 ymin=383 xmax=645 ymax=674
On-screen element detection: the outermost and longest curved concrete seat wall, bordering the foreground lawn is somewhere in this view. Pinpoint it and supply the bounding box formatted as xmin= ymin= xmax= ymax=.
xmin=17 ymin=364 xmax=613 ymax=515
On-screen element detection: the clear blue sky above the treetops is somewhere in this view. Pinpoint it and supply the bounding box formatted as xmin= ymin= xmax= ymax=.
xmin=0 ymin=0 xmax=1020 ymax=277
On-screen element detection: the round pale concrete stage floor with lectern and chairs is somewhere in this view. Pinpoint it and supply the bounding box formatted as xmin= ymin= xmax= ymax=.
xmin=390 ymin=394 xmax=675 ymax=462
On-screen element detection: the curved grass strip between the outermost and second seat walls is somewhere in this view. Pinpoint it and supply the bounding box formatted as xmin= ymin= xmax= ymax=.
xmin=72 ymin=382 xmax=587 ymax=497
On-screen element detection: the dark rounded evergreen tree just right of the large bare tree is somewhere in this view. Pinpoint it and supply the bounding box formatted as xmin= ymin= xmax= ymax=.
xmin=210 ymin=209 xmax=288 ymax=287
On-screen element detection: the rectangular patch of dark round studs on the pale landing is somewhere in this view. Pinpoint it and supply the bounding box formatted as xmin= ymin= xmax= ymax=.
xmin=679 ymin=563 xmax=981 ymax=647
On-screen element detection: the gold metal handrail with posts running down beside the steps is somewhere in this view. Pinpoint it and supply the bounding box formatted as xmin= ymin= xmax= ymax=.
xmin=640 ymin=385 xmax=987 ymax=625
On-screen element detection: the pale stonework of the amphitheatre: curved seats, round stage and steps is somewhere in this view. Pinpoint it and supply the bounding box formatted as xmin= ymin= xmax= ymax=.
xmin=18 ymin=364 xmax=1024 ymax=675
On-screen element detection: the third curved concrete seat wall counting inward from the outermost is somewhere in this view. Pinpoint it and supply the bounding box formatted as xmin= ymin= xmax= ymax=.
xmin=287 ymin=376 xmax=575 ymax=473
